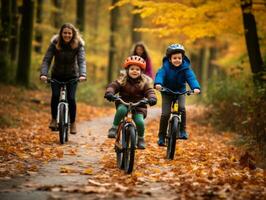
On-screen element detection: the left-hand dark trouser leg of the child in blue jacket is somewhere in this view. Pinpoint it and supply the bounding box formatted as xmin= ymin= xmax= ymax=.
xmin=159 ymin=94 xmax=172 ymax=140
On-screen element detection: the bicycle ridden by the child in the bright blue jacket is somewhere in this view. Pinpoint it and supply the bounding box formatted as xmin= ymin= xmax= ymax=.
xmin=161 ymin=87 xmax=194 ymax=160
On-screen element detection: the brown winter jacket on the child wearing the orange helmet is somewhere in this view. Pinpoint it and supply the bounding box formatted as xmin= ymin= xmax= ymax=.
xmin=106 ymin=74 xmax=157 ymax=118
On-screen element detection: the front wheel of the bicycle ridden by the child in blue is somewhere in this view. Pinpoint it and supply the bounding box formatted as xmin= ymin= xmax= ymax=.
xmin=166 ymin=117 xmax=179 ymax=160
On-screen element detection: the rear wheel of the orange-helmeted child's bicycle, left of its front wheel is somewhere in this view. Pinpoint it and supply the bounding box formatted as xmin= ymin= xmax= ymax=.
xmin=115 ymin=123 xmax=124 ymax=169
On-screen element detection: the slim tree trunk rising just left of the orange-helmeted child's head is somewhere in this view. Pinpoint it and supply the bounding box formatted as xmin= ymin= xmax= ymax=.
xmin=107 ymin=0 xmax=119 ymax=83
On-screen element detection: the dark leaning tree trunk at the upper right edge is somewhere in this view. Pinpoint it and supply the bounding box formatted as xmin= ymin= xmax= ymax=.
xmin=241 ymin=0 xmax=264 ymax=73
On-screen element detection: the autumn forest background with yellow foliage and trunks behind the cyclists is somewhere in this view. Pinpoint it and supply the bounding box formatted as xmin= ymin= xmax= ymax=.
xmin=0 ymin=0 xmax=266 ymax=164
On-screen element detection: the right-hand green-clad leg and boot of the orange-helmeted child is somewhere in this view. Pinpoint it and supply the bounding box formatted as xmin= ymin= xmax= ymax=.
xmin=133 ymin=114 xmax=146 ymax=149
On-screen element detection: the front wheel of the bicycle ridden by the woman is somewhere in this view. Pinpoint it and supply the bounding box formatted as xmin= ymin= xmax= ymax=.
xmin=58 ymin=104 xmax=68 ymax=144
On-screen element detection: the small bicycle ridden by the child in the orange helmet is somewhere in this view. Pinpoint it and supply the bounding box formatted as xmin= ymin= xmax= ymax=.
xmin=109 ymin=96 xmax=148 ymax=174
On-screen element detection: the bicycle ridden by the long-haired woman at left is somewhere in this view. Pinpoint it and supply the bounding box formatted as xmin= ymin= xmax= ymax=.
xmin=47 ymin=78 xmax=79 ymax=144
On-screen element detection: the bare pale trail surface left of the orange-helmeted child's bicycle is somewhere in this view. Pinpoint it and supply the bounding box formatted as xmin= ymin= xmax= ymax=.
xmin=0 ymin=109 xmax=174 ymax=200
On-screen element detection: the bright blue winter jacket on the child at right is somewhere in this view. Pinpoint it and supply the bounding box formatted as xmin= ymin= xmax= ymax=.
xmin=154 ymin=56 xmax=200 ymax=92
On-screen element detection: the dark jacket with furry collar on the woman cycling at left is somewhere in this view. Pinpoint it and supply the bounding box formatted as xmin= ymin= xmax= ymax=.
xmin=41 ymin=35 xmax=86 ymax=81
